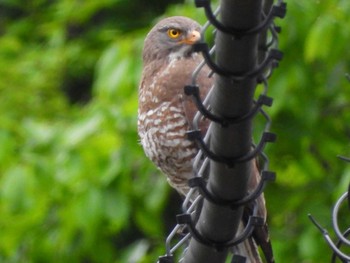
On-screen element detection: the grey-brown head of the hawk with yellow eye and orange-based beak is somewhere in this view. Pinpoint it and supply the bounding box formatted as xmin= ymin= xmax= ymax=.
xmin=143 ymin=16 xmax=201 ymax=64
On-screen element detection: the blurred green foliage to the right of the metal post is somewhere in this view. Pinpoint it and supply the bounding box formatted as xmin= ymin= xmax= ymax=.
xmin=266 ymin=1 xmax=350 ymax=262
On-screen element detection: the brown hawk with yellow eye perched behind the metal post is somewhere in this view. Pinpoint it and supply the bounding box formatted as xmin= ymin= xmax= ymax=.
xmin=137 ymin=16 xmax=274 ymax=263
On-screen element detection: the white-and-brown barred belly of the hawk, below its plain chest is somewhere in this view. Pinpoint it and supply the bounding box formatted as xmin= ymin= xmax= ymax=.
xmin=138 ymin=102 xmax=197 ymax=183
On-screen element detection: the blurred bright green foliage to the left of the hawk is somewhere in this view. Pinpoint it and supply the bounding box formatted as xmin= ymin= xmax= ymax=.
xmin=0 ymin=1 xmax=172 ymax=262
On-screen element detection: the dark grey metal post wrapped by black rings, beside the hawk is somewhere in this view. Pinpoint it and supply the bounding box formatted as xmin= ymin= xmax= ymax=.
xmin=184 ymin=0 xmax=262 ymax=263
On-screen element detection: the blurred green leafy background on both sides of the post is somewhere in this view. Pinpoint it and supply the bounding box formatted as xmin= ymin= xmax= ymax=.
xmin=0 ymin=0 xmax=350 ymax=263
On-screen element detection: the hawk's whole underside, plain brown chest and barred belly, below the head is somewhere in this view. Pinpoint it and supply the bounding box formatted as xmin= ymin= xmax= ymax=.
xmin=138 ymin=56 xmax=209 ymax=192
